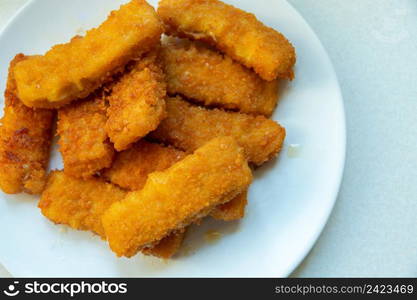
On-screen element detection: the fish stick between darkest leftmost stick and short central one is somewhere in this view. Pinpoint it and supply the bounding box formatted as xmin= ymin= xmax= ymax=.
xmin=57 ymin=95 xmax=114 ymax=178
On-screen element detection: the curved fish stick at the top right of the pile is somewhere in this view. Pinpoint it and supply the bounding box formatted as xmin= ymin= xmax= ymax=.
xmin=158 ymin=0 xmax=296 ymax=80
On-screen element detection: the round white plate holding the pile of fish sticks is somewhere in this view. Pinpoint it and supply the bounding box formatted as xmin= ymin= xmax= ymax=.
xmin=0 ymin=0 xmax=345 ymax=277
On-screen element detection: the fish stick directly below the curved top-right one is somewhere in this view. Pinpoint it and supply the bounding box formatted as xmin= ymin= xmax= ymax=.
xmin=162 ymin=39 xmax=278 ymax=116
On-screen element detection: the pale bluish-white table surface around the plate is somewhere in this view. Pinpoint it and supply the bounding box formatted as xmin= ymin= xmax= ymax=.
xmin=0 ymin=0 xmax=417 ymax=277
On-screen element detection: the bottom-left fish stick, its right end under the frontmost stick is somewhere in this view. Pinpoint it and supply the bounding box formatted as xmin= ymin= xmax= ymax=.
xmin=38 ymin=171 xmax=126 ymax=238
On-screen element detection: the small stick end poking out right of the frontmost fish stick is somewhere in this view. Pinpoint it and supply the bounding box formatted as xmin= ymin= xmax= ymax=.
xmin=210 ymin=191 xmax=248 ymax=221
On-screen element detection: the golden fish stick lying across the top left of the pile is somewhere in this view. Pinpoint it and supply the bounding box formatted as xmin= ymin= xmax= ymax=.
xmin=15 ymin=0 xmax=163 ymax=108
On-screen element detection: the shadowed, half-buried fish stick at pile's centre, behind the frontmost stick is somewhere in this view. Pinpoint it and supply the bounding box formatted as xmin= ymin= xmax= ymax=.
xmin=103 ymin=140 xmax=186 ymax=191
